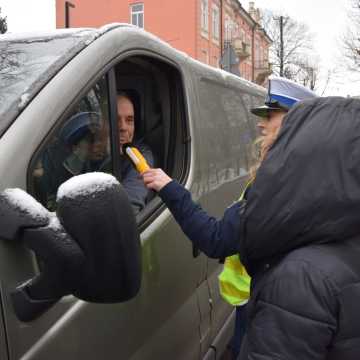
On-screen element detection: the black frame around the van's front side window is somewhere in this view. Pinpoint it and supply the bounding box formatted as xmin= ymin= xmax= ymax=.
xmin=26 ymin=50 xmax=191 ymax=228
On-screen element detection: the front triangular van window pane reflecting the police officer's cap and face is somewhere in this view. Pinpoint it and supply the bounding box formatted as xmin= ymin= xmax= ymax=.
xmin=30 ymin=77 xmax=112 ymax=211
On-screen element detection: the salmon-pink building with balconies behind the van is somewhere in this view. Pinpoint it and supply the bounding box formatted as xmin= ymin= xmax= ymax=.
xmin=56 ymin=0 xmax=271 ymax=84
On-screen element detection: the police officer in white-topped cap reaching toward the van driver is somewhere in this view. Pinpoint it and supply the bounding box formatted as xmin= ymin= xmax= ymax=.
xmin=143 ymin=77 xmax=316 ymax=359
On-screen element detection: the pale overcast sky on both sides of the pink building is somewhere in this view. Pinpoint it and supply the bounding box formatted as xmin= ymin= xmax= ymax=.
xmin=0 ymin=0 xmax=360 ymax=96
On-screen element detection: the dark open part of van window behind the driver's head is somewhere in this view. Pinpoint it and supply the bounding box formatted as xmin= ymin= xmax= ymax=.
xmin=114 ymin=56 xmax=189 ymax=207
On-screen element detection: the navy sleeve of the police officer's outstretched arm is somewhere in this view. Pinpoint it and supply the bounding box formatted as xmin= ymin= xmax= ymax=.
xmin=159 ymin=181 xmax=242 ymax=259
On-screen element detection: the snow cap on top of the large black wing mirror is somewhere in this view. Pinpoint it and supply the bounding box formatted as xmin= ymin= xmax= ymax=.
xmin=56 ymin=172 xmax=119 ymax=201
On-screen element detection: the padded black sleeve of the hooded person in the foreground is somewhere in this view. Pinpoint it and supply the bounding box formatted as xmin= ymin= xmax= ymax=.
xmin=240 ymin=261 xmax=337 ymax=360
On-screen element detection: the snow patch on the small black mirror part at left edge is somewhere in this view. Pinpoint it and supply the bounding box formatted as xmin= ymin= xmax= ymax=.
xmin=2 ymin=188 xmax=50 ymax=221
